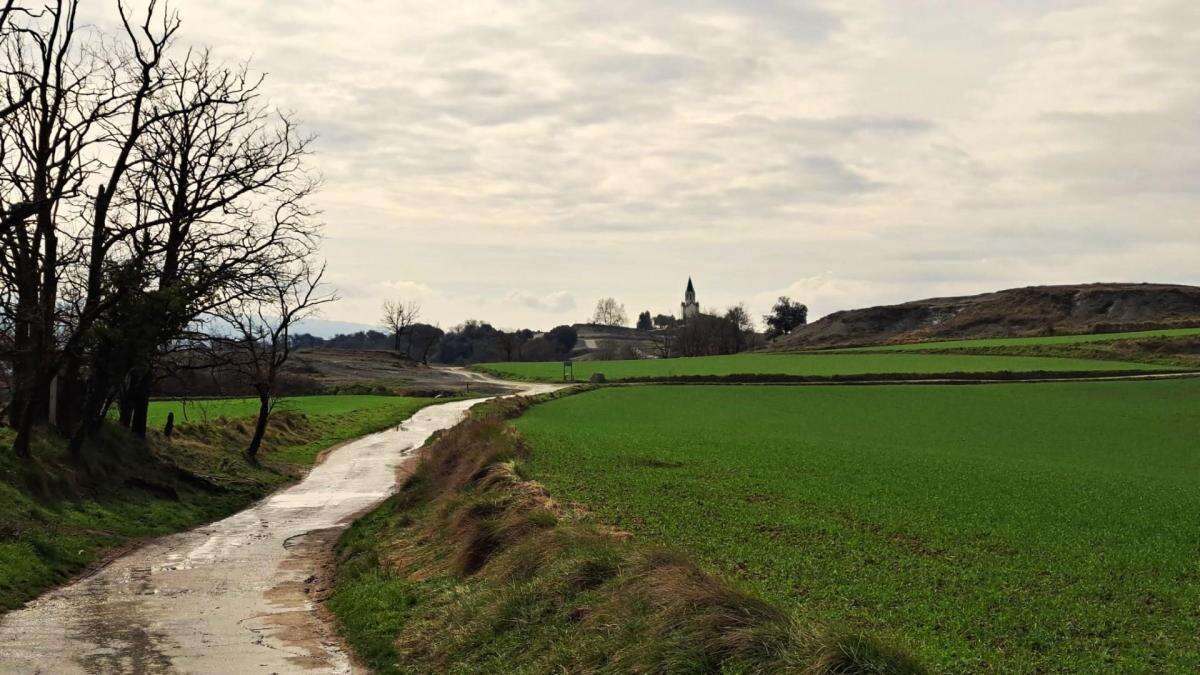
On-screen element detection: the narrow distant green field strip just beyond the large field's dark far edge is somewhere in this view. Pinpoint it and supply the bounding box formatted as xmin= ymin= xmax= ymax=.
xmin=475 ymin=353 xmax=1165 ymax=381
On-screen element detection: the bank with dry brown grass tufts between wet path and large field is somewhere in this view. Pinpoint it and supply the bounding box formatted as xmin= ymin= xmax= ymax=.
xmin=329 ymin=393 xmax=920 ymax=674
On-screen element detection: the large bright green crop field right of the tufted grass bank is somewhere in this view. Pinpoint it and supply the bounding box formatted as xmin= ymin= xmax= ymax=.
xmin=514 ymin=380 xmax=1200 ymax=673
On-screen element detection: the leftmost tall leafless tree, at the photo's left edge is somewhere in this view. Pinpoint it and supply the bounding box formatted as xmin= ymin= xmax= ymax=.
xmin=0 ymin=0 xmax=124 ymax=456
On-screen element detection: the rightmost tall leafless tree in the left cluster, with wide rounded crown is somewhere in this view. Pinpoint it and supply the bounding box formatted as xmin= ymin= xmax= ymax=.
xmin=112 ymin=52 xmax=317 ymax=435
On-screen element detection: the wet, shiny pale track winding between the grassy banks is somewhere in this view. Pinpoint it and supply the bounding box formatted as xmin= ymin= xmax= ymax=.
xmin=0 ymin=384 xmax=557 ymax=674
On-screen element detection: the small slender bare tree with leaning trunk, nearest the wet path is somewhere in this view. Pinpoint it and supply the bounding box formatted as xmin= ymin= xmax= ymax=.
xmin=214 ymin=262 xmax=337 ymax=465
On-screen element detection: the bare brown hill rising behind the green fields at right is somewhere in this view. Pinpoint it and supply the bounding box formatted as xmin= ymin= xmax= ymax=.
xmin=772 ymin=283 xmax=1200 ymax=350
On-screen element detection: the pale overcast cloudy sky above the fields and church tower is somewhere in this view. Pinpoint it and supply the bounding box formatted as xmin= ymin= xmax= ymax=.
xmin=100 ymin=0 xmax=1200 ymax=327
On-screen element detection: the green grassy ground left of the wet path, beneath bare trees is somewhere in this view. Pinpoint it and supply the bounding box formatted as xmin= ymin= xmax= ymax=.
xmin=0 ymin=396 xmax=433 ymax=610
